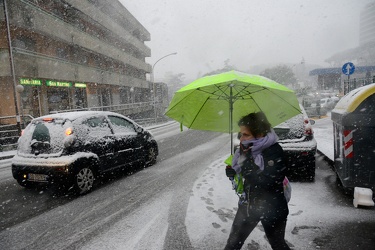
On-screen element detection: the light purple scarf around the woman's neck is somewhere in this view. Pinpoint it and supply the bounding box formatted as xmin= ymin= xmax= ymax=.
xmin=232 ymin=129 xmax=279 ymax=174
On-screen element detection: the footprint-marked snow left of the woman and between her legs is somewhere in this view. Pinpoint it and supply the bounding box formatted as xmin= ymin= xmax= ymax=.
xmin=185 ymin=156 xmax=271 ymax=249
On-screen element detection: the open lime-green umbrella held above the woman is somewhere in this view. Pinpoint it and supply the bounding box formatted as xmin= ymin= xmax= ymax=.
xmin=165 ymin=71 xmax=301 ymax=152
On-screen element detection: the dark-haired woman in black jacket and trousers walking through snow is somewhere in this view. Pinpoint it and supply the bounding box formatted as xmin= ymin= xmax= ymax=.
xmin=225 ymin=112 xmax=290 ymax=250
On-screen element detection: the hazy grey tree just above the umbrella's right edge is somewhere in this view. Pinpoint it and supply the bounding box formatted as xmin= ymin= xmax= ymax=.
xmin=260 ymin=65 xmax=297 ymax=86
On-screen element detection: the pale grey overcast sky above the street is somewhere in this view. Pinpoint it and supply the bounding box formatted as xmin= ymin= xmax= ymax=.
xmin=120 ymin=0 xmax=373 ymax=80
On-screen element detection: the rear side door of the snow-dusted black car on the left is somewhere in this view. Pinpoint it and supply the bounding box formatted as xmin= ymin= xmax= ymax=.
xmin=82 ymin=116 xmax=115 ymax=171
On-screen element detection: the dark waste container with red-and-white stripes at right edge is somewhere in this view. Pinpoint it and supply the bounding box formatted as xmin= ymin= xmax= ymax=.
xmin=331 ymin=84 xmax=375 ymax=190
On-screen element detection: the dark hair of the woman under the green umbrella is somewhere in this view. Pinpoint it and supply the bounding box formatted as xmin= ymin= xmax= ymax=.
xmin=238 ymin=112 xmax=271 ymax=138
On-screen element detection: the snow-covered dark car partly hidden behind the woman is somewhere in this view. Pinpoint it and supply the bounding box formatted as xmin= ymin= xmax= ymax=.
xmin=274 ymin=105 xmax=317 ymax=181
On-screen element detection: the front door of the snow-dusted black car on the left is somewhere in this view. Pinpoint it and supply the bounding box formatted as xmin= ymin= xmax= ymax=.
xmin=108 ymin=115 xmax=143 ymax=166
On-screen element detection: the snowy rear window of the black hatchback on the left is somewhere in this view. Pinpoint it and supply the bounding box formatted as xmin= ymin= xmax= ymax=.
xmin=18 ymin=119 xmax=71 ymax=155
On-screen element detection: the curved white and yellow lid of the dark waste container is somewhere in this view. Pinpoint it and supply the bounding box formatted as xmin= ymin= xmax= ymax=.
xmin=332 ymin=83 xmax=375 ymax=114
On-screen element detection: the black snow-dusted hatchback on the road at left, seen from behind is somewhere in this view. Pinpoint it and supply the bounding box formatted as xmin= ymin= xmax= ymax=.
xmin=12 ymin=111 xmax=158 ymax=194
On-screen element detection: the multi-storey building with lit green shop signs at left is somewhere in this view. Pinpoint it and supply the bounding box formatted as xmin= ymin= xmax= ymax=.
xmin=0 ymin=0 xmax=153 ymax=123
